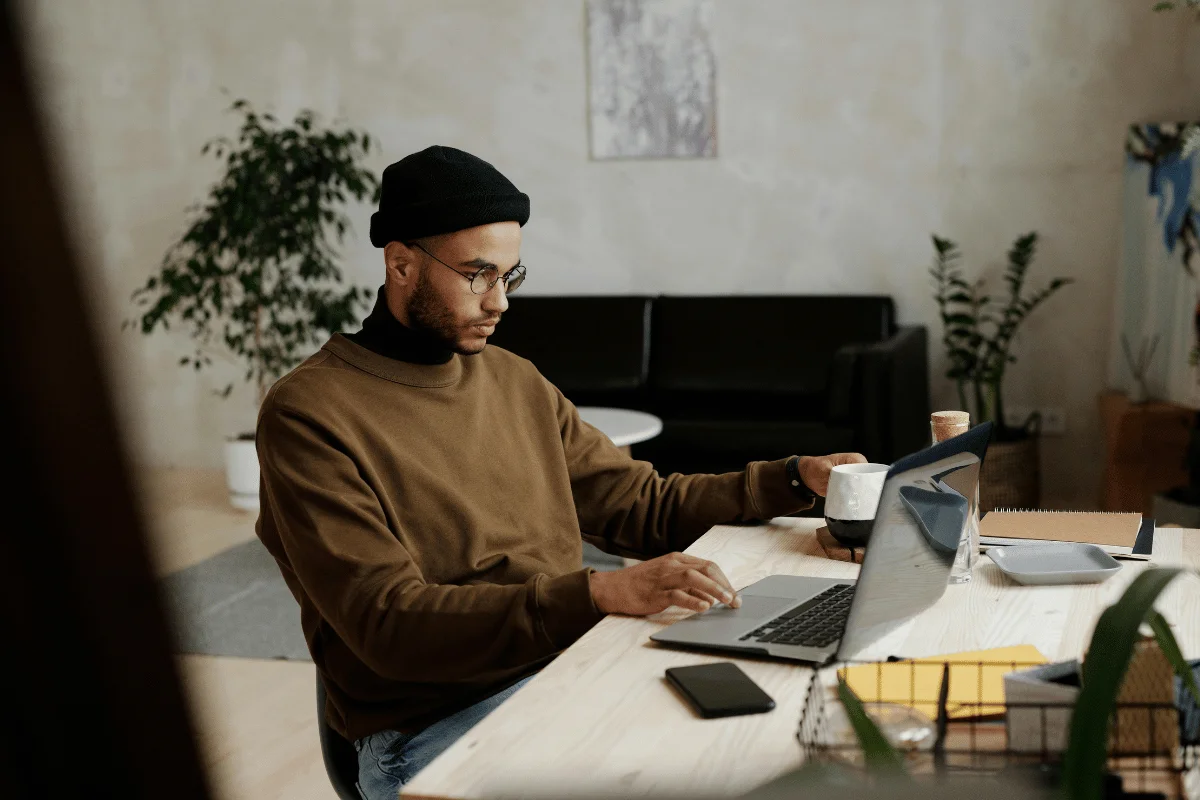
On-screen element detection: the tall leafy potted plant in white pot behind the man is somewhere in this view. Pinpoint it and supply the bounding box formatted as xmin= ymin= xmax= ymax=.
xmin=125 ymin=100 xmax=379 ymax=510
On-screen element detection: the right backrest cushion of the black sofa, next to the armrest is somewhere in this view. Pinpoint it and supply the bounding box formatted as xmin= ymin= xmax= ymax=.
xmin=650 ymin=295 xmax=895 ymax=403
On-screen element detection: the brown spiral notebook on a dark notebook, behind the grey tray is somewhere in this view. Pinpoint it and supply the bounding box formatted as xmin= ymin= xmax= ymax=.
xmin=979 ymin=509 xmax=1154 ymax=559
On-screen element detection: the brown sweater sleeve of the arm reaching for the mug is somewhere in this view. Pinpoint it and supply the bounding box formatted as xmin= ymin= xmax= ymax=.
xmin=554 ymin=389 xmax=812 ymax=558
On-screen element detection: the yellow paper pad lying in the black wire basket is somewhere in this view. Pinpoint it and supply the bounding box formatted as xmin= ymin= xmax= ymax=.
xmin=838 ymin=644 xmax=1046 ymax=720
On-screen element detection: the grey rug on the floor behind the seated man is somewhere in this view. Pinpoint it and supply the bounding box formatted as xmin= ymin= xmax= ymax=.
xmin=162 ymin=539 xmax=623 ymax=661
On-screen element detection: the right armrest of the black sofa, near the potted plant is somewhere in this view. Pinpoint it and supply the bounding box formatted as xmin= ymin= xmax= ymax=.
xmin=828 ymin=325 xmax=930 ymax=463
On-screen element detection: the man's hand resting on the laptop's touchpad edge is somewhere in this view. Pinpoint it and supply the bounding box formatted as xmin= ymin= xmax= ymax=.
xmin=590 ymin=553 xmax=742 ymax=616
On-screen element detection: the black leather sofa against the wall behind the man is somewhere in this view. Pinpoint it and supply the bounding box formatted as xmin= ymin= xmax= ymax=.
xmin=490 ymin=295 xmax=930 ymax=474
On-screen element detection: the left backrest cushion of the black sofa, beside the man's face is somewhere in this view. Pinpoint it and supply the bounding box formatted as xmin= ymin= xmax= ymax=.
xmin=488 ymin=295 xmax=650 ymax=395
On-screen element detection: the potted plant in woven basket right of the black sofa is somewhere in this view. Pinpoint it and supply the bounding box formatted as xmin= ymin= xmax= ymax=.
xmin=930 ymin=233 xmax=1072 ymax=511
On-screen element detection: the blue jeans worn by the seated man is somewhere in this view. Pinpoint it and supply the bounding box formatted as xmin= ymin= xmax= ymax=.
xmin=354 ymin=675 xmax=533 ymax=800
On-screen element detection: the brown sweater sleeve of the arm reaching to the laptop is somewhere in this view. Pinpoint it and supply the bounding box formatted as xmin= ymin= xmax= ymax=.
xmin=257 ymin=404 xmax=602 ymax=681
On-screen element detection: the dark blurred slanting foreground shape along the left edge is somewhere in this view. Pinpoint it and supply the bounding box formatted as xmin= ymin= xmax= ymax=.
xmin=0 ymin=0 xmax=209 ymax=799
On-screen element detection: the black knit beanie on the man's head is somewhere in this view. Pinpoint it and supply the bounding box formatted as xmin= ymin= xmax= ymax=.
xmin=371 ymin=145 xmax=529 ymax=247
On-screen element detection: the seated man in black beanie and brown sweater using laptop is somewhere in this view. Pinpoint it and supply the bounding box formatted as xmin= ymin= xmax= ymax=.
xmin=257 ymin=146 xmax=865 ymax=800
